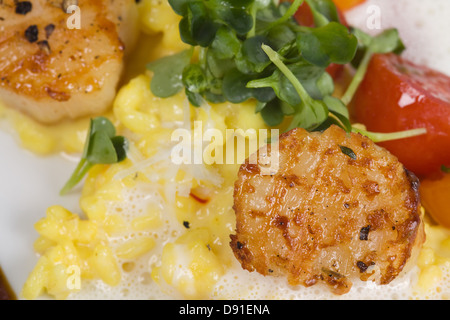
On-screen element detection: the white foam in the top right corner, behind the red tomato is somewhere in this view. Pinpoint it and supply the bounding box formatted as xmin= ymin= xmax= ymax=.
xmin=346 ymin=0 xmax=450 ymax=76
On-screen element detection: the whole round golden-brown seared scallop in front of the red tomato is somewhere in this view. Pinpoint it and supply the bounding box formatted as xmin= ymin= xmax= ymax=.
xmin=231 ymin=126 xmax=425 ymax=294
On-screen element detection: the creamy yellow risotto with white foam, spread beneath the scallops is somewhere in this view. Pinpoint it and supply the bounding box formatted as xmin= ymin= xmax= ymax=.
xmin=0 ymin=0 xmax=450 ymax=299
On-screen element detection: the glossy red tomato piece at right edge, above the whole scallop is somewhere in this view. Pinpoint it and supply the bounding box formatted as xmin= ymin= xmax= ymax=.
xmin=350 ymin=54 xmax=450 ymax=177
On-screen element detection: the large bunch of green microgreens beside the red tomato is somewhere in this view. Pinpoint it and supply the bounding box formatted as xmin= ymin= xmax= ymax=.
xmin=148 ymin=0 xmax=423 ymax=139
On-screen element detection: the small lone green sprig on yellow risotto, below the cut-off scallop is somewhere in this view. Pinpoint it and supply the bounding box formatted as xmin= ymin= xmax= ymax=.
xmin=60 ymin=117 xmax=128 ymax=195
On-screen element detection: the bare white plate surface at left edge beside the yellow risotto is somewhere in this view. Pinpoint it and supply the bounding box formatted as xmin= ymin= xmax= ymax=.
xmin=0 ymin=126 xmax=79 ymax=295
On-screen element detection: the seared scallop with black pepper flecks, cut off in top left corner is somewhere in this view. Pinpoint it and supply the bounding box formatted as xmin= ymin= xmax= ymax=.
xmin=0 ymin=0 xmax=138 ymax=124
